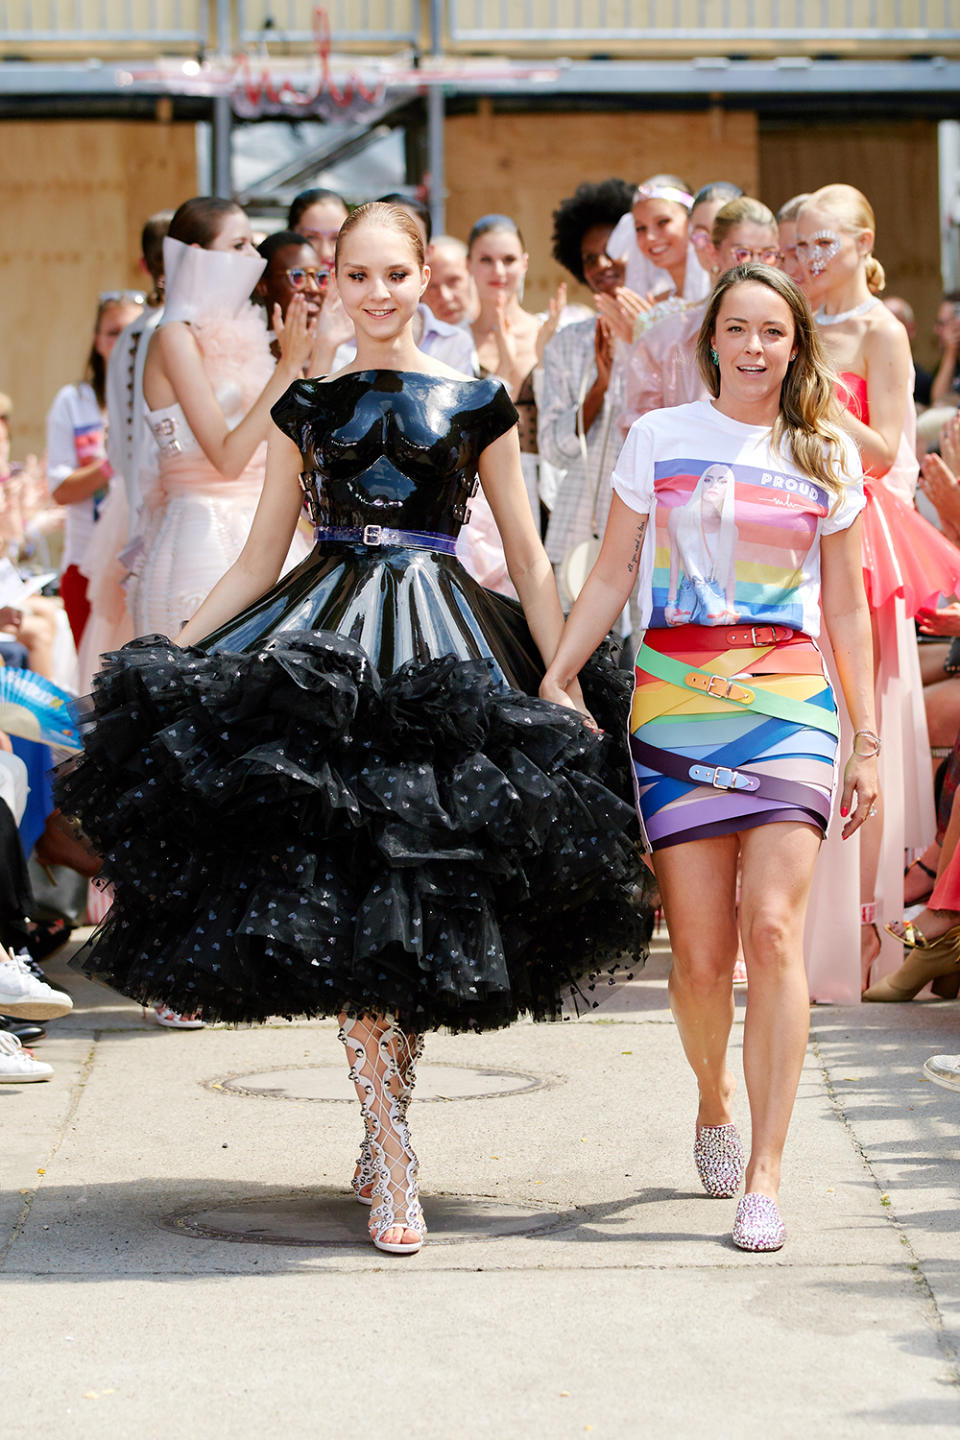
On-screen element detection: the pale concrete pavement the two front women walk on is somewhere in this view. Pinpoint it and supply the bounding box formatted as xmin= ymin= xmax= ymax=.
xmin=0 ymin=927 xmax=960 ymax=1440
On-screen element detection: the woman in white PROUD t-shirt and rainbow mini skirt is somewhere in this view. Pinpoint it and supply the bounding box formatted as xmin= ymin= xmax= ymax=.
xmin=540 ymin=262 xmax=878 ymax=1250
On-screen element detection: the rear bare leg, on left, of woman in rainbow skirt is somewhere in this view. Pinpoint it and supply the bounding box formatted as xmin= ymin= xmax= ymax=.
xmin=653 ymin=835 xmax=737 ymax=1125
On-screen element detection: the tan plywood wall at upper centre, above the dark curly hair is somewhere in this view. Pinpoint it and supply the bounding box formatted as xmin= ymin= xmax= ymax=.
xmin=446 ymin=102 xmax=759 ymax=310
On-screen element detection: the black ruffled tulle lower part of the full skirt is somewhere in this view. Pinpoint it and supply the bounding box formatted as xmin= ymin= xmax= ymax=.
xmin=56 ymin=544 xmax=649 ymax=1031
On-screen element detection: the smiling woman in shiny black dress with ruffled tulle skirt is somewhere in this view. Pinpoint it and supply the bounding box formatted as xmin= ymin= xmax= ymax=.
xmin=60 ymin=204 xmax=646 ymax=1254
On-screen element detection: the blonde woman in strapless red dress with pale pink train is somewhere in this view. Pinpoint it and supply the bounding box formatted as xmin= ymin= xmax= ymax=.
xmin=796 ymin=184 xmax=960 ymax=999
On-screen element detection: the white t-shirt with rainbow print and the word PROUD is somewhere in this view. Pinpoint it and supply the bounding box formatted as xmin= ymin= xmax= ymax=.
xmin=612 ymin=400 xmax=864 ymax=636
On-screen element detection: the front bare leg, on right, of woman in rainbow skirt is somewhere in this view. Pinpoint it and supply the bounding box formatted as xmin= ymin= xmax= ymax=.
xmin=740 ymin=824 xmax=820 ymax=1201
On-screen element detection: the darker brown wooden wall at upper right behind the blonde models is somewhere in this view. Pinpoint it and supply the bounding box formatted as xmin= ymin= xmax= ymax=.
xmin=760 ymin=118 xmax=941 ymax=364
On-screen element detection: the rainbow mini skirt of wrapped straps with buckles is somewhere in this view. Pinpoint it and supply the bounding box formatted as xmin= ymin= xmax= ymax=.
xmin=630 ymin=625 xmax=839 ymax=850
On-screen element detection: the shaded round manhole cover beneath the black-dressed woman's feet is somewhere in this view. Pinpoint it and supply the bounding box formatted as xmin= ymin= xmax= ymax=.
xmin=163 ymin=1191 xmax=577 ymax=1247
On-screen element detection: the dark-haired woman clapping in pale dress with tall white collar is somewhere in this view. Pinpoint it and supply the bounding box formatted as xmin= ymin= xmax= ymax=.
xmin=131 ymin=196 xmax=314 ymax=636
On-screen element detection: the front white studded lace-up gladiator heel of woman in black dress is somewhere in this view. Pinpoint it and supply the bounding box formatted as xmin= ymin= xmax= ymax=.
xmin=340 ymin=1018 xmax=426 ymax=1254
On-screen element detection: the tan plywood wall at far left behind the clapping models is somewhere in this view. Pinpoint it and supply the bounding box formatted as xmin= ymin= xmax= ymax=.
xmin=0 ymin=120 xmax=197 ymax=458
